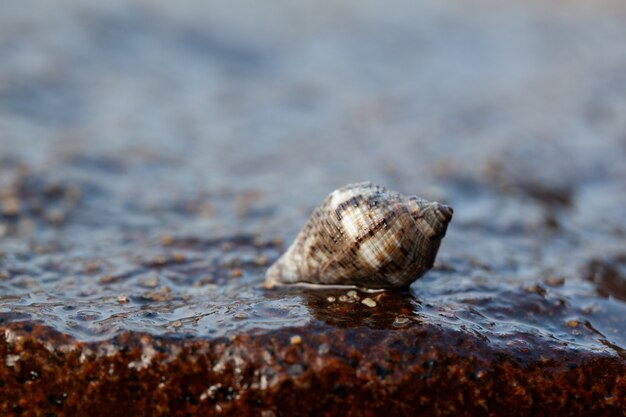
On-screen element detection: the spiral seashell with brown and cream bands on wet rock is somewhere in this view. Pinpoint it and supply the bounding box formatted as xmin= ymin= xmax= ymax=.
xmin=264 ymin=182 xmax=453 ymax=289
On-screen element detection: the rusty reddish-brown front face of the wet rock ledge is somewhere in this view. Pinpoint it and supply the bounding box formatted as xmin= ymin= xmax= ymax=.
xmin=0 ymin=322 xmax=626 ymax=417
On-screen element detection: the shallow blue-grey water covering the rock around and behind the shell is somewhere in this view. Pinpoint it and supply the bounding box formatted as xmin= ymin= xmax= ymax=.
xmin=0 ymin=1 xmax=626 ymax=357
